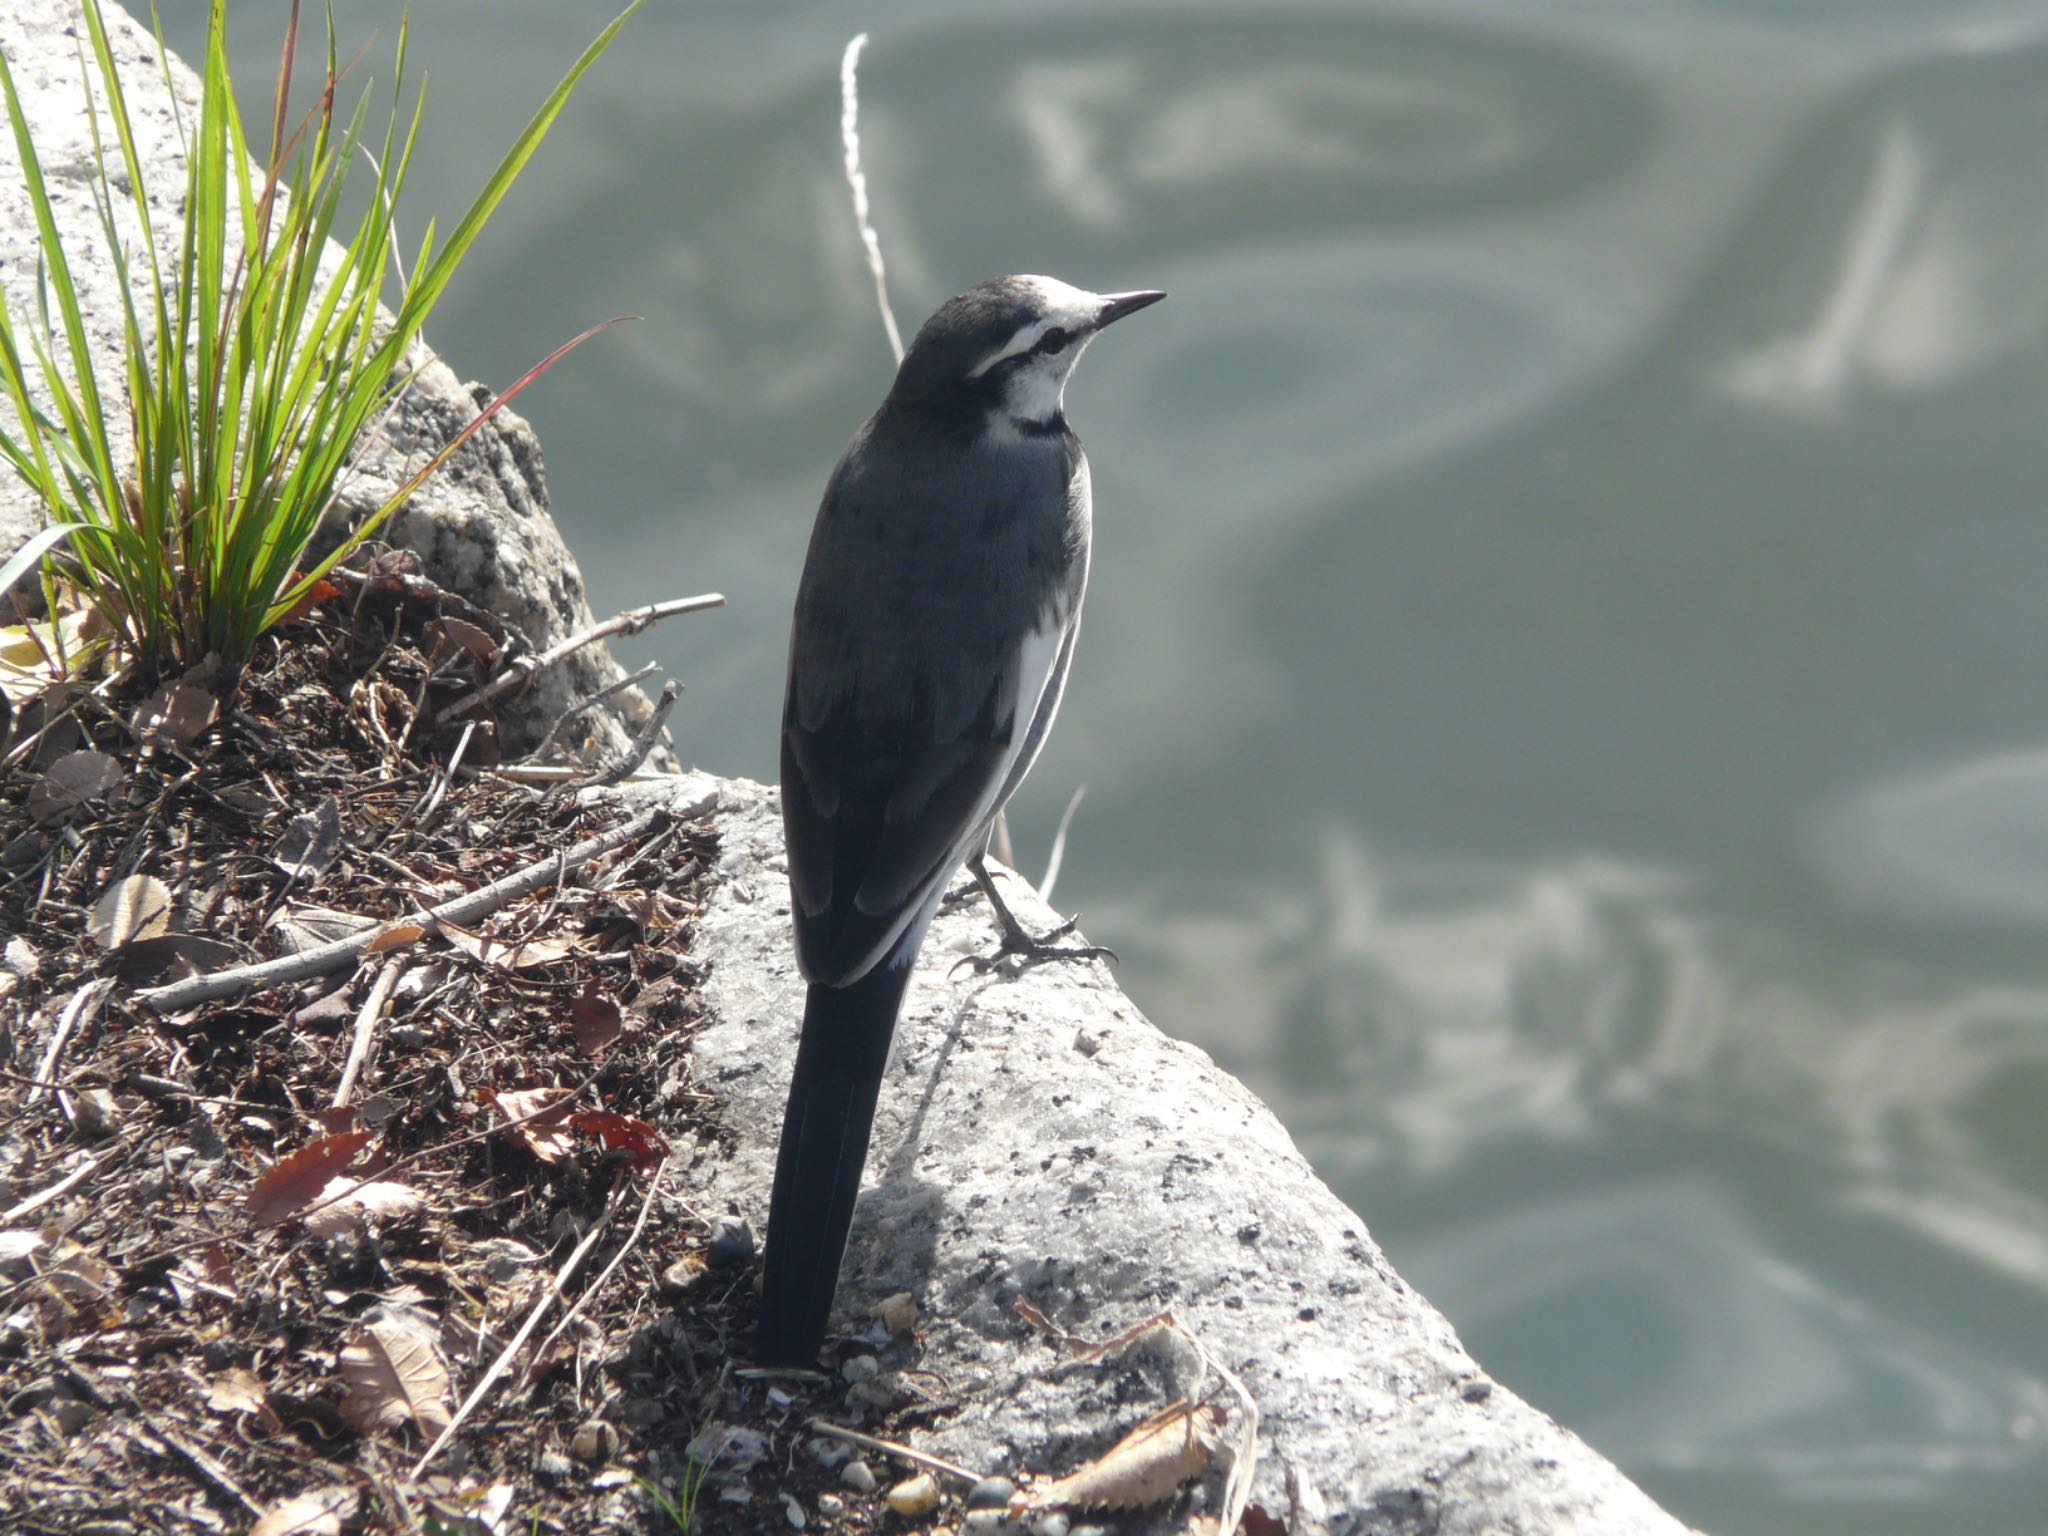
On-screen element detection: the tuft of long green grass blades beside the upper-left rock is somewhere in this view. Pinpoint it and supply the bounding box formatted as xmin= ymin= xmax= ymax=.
xmin=0 ymin=0 xmax=643 ymax=678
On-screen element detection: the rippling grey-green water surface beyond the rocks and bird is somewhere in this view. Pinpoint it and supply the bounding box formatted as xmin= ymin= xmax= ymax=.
xmin=166 ymin=0 xmax=2048 ymax=1536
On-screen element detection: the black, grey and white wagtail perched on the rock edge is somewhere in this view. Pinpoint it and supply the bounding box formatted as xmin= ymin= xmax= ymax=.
xmin=754 ymin=276 xmax=1165 ymax=1366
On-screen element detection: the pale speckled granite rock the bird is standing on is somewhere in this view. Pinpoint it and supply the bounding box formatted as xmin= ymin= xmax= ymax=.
xmin=680 ymin=780 xmax=1683 ymax=1536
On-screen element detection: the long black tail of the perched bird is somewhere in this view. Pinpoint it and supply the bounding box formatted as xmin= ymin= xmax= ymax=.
xmin=754 ymin=962 xmax=915 ymax=1366
